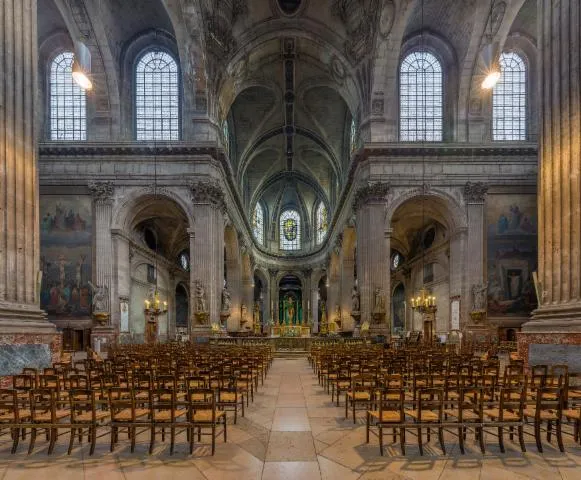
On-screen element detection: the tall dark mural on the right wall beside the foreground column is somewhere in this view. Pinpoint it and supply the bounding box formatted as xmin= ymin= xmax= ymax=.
xmin=486 ymin=195 xmax=537 ymax=317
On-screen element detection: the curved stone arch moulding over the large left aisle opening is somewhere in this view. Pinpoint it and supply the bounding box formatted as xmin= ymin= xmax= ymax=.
xmin=111 ymin=186 xmax=195 ymax=231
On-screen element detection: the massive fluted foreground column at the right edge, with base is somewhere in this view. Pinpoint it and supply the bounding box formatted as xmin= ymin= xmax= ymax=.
xmin=518 ymin=0 xmax=581 ymax=363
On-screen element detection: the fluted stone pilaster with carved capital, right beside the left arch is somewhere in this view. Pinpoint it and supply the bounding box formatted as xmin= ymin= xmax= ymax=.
xmin=190 ymin=180 xmax=226 ymax=333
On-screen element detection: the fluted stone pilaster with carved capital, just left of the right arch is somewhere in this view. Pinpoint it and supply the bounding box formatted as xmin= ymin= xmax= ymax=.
xmin=353 ymin=182 xmax=389 ymax=334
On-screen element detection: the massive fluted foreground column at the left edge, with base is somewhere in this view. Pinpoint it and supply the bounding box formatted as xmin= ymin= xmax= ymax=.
xmin=0 ymin=0 xmax=60 ymax=375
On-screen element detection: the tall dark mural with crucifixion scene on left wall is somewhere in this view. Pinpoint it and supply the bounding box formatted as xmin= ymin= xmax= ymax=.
xmin=40 ymin=195 xmax=92 ymax=320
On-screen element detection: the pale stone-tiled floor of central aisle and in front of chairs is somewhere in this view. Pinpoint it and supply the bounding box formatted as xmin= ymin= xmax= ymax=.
xmin=0 ymin=359 xmax=581 ymax=480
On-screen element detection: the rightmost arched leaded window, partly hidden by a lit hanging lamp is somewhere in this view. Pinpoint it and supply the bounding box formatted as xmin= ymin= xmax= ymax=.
xmin=492 ymin=52 xmax=527 ymax=140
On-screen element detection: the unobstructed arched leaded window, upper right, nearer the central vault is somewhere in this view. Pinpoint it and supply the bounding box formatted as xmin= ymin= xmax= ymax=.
xmin=399 ymin=52 xmax=443 ymax=142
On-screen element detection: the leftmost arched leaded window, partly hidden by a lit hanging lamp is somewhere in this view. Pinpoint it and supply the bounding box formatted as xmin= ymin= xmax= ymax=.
xmin=49 ymin=52 xmax=87 ymax=140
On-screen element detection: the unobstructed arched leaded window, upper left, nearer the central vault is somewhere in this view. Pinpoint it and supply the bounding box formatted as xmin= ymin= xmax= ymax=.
xmin=135 ymin=51 xmax=180 ymax=140
